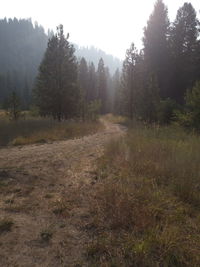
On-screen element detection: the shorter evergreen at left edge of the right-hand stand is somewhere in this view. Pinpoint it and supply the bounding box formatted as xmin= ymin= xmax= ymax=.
xmin=120 ymin=44 xmax=160 ymax=122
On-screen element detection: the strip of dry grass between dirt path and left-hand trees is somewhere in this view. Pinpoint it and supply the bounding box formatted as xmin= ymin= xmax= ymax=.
xmin=0 ymin=118 xmax=102 ymax=146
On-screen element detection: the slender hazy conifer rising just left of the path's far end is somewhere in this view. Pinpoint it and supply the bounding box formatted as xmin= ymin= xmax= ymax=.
xmin=97 ymin=58 xmax=107 ymax=114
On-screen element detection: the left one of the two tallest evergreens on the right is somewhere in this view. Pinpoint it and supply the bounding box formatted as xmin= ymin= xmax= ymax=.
xmin=143 ymin=0 xmax=171 ymax=98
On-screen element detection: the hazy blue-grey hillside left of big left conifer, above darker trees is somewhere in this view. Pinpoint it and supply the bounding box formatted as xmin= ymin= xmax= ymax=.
xmin=0 ymin=18 xmax=48 ymax=75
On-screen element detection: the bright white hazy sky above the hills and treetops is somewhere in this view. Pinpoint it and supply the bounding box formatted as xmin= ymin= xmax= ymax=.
xmin=0 ymin=0 xmax=200 ymax=58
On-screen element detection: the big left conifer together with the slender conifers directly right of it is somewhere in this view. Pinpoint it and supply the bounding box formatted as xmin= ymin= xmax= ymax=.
xmin=34 ymin=25 xmax=114 ymax=121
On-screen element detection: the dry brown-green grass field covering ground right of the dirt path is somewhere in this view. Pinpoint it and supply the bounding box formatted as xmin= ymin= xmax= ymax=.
xmin=87 ymin=126 xmax=200 ymax=267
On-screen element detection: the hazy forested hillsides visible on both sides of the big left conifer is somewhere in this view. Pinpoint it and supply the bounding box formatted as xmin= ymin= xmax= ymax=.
xmin=0 ymin=18 xmax=122 ymax=107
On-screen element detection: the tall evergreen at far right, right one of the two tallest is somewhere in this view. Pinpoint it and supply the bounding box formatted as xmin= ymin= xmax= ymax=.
xmin=170 ymin=3 xmax=199 ymax=103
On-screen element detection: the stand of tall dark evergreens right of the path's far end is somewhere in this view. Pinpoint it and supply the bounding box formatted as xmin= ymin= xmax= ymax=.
xmin=115 ymin=0 xmax=200 ymax=129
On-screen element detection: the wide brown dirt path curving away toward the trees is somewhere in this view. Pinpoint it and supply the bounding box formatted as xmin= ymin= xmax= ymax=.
xmin=0 ymin=121 xmax=124 ymax=267
